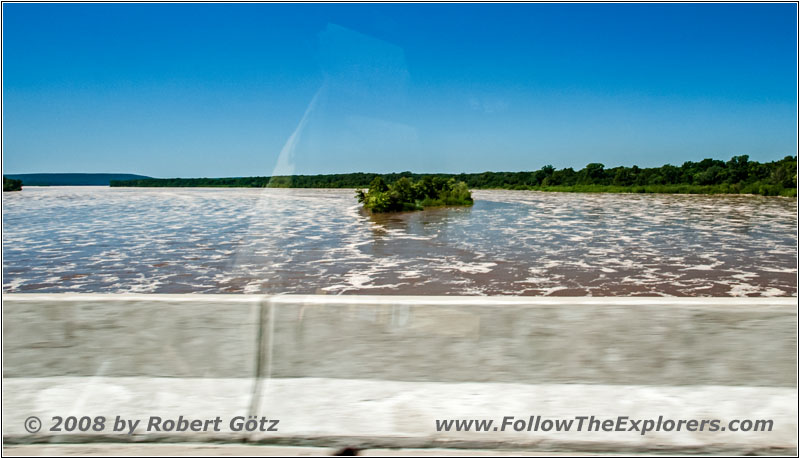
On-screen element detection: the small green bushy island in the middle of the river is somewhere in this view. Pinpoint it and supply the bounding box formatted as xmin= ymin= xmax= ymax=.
xmin=356 ymin=176 xmax=473 ymax=213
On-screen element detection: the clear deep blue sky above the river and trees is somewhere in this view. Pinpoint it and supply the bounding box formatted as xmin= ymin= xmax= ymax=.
xmin=3 ymin=3 xmax=797 ymax=177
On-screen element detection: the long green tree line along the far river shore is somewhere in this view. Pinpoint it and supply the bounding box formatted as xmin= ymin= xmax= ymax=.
xmin=104 ymin=155 xmax=797 ymax=197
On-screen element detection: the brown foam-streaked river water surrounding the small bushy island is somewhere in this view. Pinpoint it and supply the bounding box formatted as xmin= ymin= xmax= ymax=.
xmin=3 ymin=187 xmax=797 ymax=296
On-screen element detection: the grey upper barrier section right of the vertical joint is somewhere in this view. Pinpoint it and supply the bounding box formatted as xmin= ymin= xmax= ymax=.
xmin=264 ymin=296 xmax=797 ymax=387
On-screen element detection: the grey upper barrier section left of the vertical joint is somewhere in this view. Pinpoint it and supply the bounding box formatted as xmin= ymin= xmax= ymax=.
xmin=3 ymin=294 xmax=263 ymax=378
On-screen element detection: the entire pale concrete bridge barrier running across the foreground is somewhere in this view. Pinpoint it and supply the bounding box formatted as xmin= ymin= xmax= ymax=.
xmin=3 ymin=294 xmax=797 ymax=454
